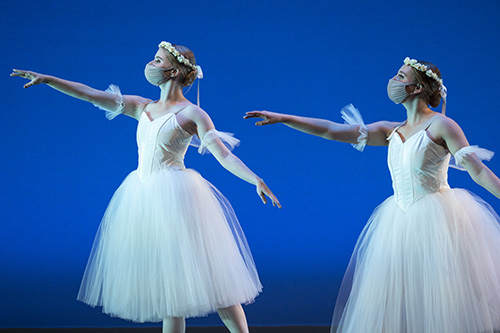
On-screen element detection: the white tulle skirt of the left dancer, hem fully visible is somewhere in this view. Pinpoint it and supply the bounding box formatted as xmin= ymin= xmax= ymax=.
xmin=78 ymin=169 xmax=262 ymax=322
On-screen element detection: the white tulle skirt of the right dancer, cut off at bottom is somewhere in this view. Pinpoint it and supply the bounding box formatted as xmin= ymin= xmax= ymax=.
xmin=332 ymin=189 xmax=500 ymax=333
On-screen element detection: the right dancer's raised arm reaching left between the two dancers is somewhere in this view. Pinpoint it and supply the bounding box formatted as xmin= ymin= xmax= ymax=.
xmin=243 ymin=111 xmax=397 ymax=146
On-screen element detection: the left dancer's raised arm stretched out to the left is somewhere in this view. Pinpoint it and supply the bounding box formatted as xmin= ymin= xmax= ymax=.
xmin=10 ymin=69 xmax=149 ymax=118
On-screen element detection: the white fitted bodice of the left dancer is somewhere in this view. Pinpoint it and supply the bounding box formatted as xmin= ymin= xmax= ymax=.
xmin=137 ymin=112 xmax=192 ymax=180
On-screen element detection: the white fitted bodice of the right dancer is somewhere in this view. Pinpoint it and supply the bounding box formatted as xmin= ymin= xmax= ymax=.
xmin=387 ymin=128 xmax=451 ymax=211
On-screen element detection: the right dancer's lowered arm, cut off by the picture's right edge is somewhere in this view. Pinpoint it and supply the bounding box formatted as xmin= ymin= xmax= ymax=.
xmin=436 ymin=117 xmax=500 ymax=199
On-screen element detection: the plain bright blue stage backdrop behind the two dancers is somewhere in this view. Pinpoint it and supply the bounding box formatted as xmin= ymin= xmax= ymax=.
xmin=0 ymin=0 xmax=500 ymax=327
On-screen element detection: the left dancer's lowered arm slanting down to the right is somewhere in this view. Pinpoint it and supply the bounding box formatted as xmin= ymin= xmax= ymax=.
xmin=186 ymin=107 xmax=281 ymax=208
